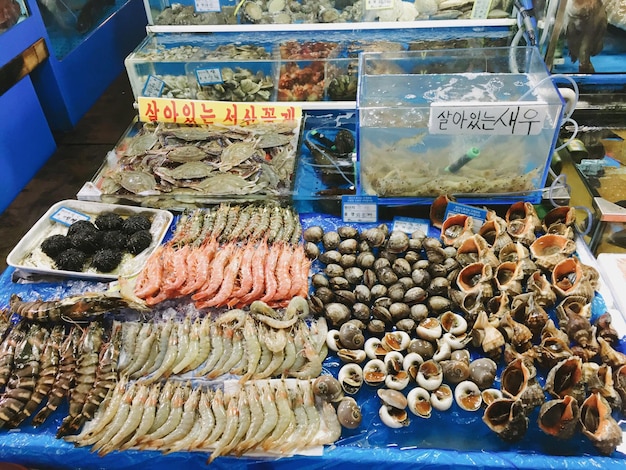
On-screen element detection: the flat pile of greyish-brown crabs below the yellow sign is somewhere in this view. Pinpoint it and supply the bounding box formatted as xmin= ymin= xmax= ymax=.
xmin=97 ymin=122 xmax=297 ymax=203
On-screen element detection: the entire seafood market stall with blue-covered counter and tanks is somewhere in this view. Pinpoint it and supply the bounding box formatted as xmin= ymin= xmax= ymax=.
xmin=0 ymin=0 xmax=626 ymax=469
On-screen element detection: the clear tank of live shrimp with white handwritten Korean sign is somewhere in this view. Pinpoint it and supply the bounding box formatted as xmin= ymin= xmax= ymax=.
xmin=357 ymin=47 xmax=563 ymax=201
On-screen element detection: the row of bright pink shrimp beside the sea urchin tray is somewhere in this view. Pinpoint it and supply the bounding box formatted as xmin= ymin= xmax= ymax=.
xmin=135 ymin=239 xmax=310 ymax=308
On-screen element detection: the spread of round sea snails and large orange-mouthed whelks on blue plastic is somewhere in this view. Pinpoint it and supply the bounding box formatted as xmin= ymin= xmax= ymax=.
xmin=303 ymin=202 xmax=626 ymax=454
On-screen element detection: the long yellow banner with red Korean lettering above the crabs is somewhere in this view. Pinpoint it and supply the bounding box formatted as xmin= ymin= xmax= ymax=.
xmin=137 ymin=96 xmax=302 ymax=126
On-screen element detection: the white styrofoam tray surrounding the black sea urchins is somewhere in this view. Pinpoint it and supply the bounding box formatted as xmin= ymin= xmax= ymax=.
xmin=7 ymin=200 xmax=173 ymax=281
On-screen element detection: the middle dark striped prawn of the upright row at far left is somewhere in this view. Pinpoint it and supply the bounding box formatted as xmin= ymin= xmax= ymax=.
xmin=32 ymin=326 xmax=82 ymax=426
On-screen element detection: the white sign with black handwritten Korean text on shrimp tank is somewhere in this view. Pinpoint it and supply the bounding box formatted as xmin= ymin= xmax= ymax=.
xmin=428 ymin=103 xmax=548 ymax=135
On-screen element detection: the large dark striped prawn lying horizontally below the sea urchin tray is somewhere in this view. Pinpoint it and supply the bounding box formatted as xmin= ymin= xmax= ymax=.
xmin=9 ymin=292 xmax=147 ymax=322
